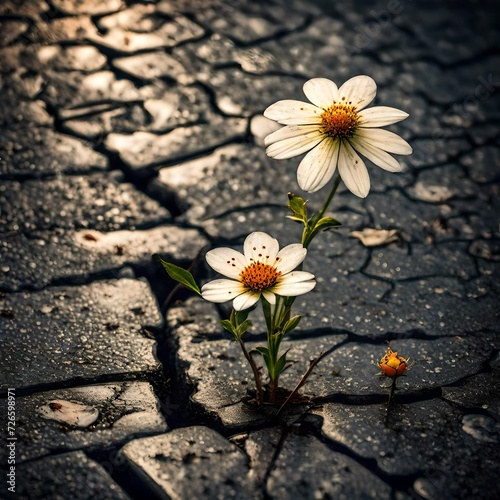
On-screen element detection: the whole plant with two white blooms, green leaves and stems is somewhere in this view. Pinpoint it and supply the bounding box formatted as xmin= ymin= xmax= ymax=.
xmin=160 ymin=75 xmax=412 ymax=404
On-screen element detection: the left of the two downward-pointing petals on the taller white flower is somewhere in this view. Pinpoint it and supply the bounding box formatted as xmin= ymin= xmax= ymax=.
xmin=297 ymin=139 xmax=340 ymax=193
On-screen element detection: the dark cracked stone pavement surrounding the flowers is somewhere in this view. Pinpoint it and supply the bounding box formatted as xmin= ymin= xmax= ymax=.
xmin=0 ymin=0 xmax=500 ymax=500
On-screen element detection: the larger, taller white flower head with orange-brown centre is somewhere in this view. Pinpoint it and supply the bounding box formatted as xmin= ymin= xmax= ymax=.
xmin=264 ymin=75 xmax=412 ymax=198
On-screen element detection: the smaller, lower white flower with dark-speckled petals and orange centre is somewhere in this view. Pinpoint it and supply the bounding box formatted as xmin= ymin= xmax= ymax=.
xmin=201 ymin=232 xmax=316 ymax=311
